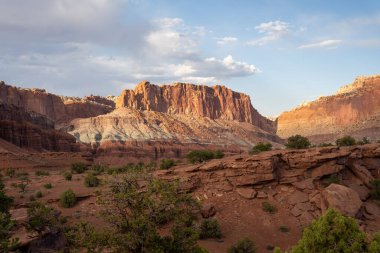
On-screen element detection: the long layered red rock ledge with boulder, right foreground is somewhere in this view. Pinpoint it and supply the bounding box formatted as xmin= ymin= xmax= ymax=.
xmin=155 ymin=144 xmax=380 ymax=229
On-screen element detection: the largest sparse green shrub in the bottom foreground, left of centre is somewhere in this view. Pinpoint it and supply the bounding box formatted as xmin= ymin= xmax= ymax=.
xmin=99 ymin=172 xmax=201 ymax=253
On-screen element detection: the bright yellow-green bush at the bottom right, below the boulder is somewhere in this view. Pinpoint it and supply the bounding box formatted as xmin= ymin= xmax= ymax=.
xmin=291 ymin=209 xmax=366 ymax=253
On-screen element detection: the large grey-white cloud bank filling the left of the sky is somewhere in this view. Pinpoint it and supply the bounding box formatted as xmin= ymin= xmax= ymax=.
xmin=0 ymin=0 xmax=258 ymax=96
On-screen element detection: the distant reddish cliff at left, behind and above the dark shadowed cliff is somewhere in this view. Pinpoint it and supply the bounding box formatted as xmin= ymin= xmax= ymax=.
xmin=0 ymin=82 xmax=115 ymax=123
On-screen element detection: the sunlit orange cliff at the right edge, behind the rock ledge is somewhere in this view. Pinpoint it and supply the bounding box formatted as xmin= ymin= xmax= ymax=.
xmin=277 ymin=75 xmax=380 ymax=141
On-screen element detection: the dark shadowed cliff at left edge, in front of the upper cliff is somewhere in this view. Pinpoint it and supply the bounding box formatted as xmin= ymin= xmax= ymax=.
xmin=0 ymin=103 xmax=79 ymax=152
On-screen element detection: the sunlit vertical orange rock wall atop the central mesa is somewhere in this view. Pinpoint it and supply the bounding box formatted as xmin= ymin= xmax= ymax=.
xmin=116 ymin=81 xmax=274 ymax=132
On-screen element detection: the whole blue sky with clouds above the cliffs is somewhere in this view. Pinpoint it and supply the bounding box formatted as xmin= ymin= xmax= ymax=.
xmin=0 ymin=0 xmax=380 ymax=116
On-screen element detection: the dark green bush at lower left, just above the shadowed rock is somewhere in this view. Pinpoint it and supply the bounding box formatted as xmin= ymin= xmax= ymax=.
xmin=25 ymin=202 xmax=59 ymax=235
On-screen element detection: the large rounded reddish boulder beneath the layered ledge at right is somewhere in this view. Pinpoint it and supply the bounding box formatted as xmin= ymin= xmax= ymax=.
xmin=321 ymin=184 xmax=362 ymax=217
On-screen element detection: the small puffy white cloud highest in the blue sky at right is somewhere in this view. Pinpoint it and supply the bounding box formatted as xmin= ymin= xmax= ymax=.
xmin=247 ymin=20 xmax=290 ymax=46
